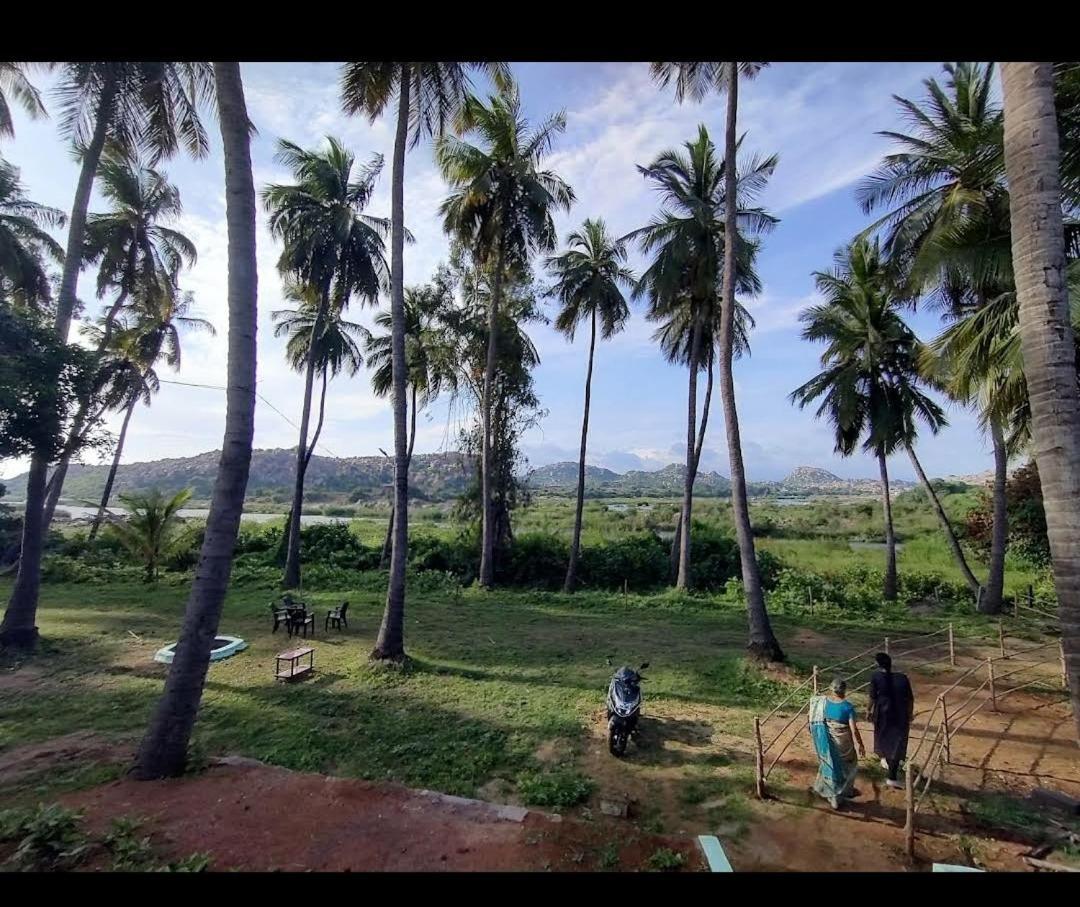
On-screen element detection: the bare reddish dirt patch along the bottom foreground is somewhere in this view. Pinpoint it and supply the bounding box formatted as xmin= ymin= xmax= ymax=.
xmin=63 ymin=760 xmax=704 ymax=871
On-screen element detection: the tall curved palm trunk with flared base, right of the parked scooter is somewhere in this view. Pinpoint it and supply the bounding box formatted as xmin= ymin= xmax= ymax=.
xmin=720 ymin=63 xmax=784 ymax=661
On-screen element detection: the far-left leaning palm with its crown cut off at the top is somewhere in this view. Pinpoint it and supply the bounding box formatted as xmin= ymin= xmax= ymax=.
xmin=8 ymin=62 xmax=215 ymax=645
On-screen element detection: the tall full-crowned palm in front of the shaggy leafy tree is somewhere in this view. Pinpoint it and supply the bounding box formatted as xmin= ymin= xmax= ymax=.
xmin=435 ymin=86 xmax=573 ymax=588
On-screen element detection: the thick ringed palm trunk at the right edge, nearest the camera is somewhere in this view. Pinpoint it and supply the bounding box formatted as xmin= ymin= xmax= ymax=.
xmin=1001 ymin=63 xmax=1080 ymax=735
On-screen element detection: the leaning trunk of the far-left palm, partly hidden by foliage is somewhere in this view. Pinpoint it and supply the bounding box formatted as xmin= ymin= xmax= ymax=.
xmin=0 ymin=81 xmax=117 ymax=646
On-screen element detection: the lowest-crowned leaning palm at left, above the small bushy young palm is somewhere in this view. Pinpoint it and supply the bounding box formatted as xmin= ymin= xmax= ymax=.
xmin=89 ymin=279 xmax=216 ymax=541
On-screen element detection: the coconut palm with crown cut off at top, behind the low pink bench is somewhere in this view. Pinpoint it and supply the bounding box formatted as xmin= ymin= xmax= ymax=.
xmin=341 ymin=60 xmax=510 ymax=661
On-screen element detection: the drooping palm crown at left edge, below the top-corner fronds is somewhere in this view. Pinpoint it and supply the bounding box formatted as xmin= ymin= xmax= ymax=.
xmin=0 ymin=160 xmax=65 ymax=308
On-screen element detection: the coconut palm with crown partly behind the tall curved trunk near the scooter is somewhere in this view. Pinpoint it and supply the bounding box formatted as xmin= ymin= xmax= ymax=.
xmin=630 ymin=125 xmax=777 ymax=604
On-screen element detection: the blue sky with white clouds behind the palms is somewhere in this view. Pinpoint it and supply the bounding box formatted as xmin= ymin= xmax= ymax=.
xmin=0 ymin=63 xmax=993 ymax=480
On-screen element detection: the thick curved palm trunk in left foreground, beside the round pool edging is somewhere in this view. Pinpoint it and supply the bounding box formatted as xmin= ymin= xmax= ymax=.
xmin=134 ymin=63 xmax=258 ymax=779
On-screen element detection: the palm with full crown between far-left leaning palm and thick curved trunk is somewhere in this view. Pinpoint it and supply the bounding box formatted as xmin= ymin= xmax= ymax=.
xmin=42 ymin=143 xmax=197 ymax=531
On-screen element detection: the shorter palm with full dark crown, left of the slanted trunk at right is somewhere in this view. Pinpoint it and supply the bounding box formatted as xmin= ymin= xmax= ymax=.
xmin=791 ymin=238 xmax=946 ymax=601
